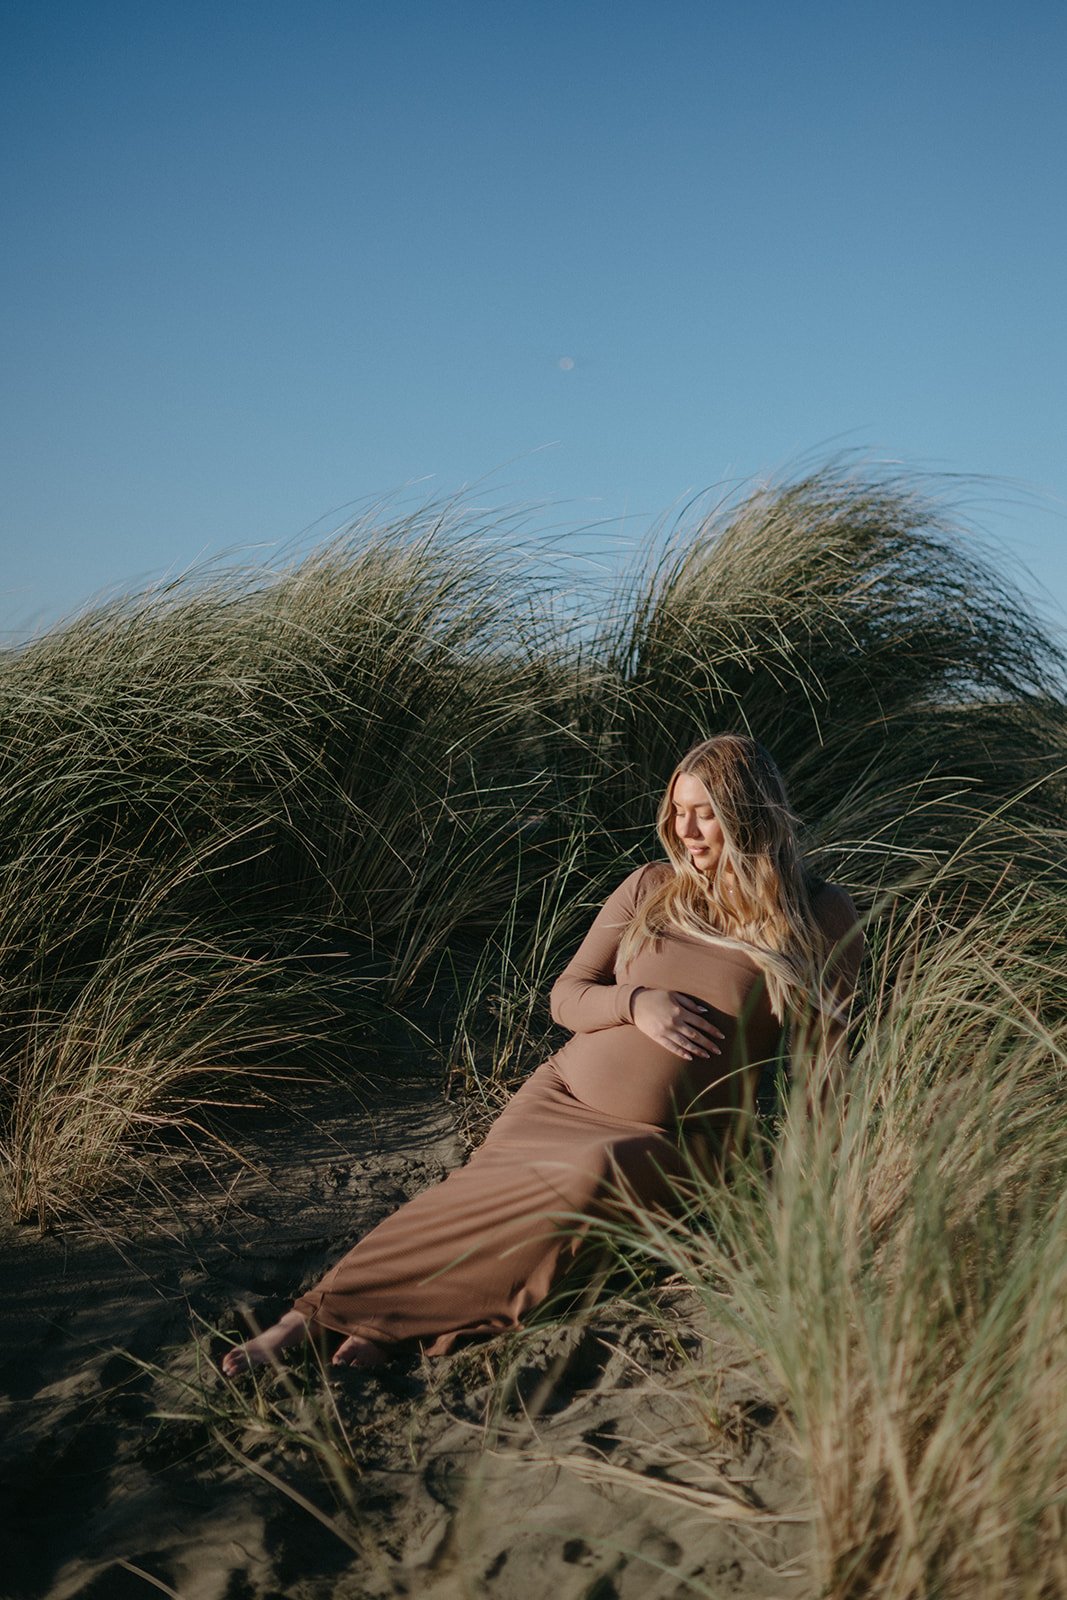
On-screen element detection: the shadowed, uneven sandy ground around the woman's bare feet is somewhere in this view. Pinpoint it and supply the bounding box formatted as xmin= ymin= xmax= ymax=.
xmin=0 ymin=1082 xmax=816 ymax=1600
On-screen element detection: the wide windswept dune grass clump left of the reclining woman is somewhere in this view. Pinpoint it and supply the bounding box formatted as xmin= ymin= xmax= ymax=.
xmin=0 ymin=520 xmax=588 ymax=1221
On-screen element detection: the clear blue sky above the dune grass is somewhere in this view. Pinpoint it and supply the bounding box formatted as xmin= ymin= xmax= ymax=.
xmin=0 ymin=0 xmax=1067 ymax=638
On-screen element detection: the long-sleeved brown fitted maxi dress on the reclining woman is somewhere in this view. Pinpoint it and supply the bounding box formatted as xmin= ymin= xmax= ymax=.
xmin=294 ymin=862 xmax=856 ymax=1355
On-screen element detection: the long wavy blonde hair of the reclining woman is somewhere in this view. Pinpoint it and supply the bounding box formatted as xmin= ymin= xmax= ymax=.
xmin=619 ymin=733 xmax=835 ymax=1021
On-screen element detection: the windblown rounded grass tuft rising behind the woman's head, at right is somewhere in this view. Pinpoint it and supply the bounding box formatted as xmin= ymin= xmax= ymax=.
xmin=591 ymin=470 xmax=1067 ymax=888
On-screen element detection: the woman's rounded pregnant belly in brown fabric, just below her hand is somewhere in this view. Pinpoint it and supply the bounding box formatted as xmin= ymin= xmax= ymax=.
xmin=552 ymin=1018 xmax=758 ymax=1130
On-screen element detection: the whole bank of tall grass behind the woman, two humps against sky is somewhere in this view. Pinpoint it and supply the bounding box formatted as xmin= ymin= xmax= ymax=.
xmin=0 ymin=469 xmax=1064 ymax=1222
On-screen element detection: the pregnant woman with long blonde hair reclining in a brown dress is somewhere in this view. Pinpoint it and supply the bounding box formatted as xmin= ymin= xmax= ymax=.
xmin=222 ymin=734 xmax=862 ymax=1378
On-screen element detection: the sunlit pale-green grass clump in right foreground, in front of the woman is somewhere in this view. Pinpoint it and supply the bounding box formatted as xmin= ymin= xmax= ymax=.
xmin=591 ymin=864 xmax=1067 ymax=1600
